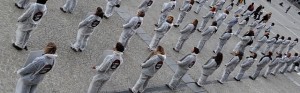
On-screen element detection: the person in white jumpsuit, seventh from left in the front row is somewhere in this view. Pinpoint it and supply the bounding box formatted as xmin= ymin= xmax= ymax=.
xmin=233 ymin=53 xmax=257 ymax=81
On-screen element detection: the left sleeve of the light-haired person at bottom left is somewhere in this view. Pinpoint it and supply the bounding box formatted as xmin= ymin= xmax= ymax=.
xmin=17 ymin=58 xmax=42 ymax=75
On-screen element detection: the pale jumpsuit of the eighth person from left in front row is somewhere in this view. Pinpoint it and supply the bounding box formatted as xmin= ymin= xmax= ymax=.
xmin=251 ymin=56 xmax=271 ymax=79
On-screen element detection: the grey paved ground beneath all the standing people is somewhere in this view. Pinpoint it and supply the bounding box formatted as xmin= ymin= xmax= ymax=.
xmin=0 ymin=0 xmax=300 ymax=93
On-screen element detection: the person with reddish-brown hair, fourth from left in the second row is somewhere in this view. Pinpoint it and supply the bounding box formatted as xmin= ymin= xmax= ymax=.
xmin=149 ymin=16 xmax=174 ymax=50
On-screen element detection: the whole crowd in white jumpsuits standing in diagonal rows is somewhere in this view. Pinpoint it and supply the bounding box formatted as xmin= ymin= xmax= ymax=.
xmin=12 ymin=0 xmax=300 ymax=93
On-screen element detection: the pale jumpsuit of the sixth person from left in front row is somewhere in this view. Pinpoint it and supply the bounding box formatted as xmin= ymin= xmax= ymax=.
xmin=220 ymin=56 xmax=240 ymax=82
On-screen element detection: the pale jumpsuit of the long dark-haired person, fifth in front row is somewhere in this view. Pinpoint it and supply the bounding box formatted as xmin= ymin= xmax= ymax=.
xmin=197 ymin=59 xmax=219 ymax=85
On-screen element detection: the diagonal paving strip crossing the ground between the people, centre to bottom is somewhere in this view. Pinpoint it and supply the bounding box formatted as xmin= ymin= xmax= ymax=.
xmin=116 ymin=5 xmax=207 ymax=93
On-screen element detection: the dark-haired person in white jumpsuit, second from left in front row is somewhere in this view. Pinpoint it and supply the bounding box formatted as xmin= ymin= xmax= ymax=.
xmin=87 ymin=43 xmax=124 ymax=93
